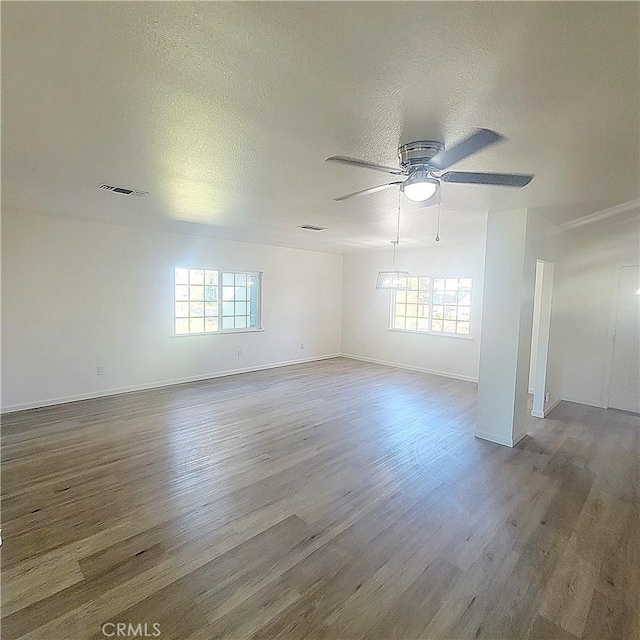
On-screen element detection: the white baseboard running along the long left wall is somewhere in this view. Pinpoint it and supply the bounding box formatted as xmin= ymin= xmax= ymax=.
xmin=0 ymin=353 xmax=341 ymax=414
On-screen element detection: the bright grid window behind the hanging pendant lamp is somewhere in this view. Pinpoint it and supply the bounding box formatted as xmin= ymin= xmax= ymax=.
xmin=389 ymin=276 xmax=472 ymax=335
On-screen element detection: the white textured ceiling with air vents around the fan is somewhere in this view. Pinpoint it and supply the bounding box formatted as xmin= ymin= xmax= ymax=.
xmin=2 ymin=2 xmax=640 ymax=252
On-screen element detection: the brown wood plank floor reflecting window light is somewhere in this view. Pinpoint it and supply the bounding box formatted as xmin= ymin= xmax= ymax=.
xmin=1 ymin=358 xmax=640 ymax=640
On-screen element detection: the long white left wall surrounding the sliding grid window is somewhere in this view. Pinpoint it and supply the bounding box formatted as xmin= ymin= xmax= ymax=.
xmin=2 ymin=212 xmax=342 ymax=410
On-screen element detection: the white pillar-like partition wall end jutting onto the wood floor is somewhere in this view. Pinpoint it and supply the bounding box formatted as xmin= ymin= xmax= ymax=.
xmin=476 ymin=209 xmax=560 ymax=446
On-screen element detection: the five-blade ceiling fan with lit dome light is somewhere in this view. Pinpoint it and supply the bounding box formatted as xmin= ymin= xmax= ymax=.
xmin=326 ymin=129 xmax=534 ymax=202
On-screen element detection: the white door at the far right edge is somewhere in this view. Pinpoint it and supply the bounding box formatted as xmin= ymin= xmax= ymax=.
xmin=608 ymin=266 xmax=640 ymax=413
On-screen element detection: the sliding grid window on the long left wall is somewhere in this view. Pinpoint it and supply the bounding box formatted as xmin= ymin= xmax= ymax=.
xmin=174 ymin=267 xmax=261 ymax=335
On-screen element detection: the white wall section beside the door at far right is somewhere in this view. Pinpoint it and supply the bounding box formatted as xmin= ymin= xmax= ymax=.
xmin=554 ymin=220 xmax=640 ymax=407
